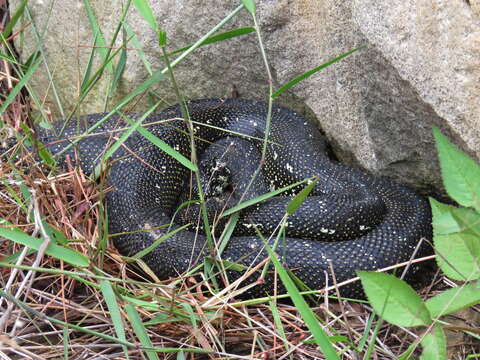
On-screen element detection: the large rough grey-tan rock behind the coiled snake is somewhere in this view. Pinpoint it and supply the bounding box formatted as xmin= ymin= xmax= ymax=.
xmin=11 ymin=0 xmax=480 ymax=194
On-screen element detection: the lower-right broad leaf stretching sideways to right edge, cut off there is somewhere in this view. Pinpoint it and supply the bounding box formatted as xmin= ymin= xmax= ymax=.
xmin=425 ymin=283 xmax=480 ymax=318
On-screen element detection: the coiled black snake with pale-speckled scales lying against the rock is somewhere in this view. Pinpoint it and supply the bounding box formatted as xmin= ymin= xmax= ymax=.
xmin=41 ymin=99 xmax=432 ymax=297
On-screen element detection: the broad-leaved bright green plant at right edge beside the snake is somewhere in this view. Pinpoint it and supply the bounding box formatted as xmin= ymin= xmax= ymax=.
xmin=358 ymin=128 xmax=480 ymax=360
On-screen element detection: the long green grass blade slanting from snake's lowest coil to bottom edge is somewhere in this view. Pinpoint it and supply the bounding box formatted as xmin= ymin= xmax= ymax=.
xmin=265 ymin=244 xmax=339 ymax=360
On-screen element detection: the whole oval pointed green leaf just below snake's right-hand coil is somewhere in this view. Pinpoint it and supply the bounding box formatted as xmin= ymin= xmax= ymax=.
xmin=357 ymin=271 xmax=432 ymax=326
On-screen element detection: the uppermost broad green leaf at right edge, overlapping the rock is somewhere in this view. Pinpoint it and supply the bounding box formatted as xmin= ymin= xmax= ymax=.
xmin=433 ymin=127 xmax=480 ymax=212
